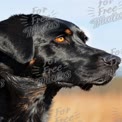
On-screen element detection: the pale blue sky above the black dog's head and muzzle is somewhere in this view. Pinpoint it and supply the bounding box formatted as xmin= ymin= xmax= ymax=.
xmin=0 ymin=0 xmax=122 ymax=65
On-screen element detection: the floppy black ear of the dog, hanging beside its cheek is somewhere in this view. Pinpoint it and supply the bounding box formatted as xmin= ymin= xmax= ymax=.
xmin=0 ymin=15 xmax=34 ymax=64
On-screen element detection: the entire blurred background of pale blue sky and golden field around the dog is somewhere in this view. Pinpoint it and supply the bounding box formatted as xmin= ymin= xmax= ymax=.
xmin=0 ymin=0 xmax=122 ymax=122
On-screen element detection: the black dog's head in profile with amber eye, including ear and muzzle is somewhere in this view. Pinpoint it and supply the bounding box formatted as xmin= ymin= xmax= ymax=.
xmin=0 ymin=15 xmax=121 ymax=90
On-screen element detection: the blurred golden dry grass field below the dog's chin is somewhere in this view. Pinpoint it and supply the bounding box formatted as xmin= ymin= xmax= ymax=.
xmin=49 ymin=78 xmax=122 ymax=122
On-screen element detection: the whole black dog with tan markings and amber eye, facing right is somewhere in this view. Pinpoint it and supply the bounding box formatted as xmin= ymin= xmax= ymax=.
xmin=0 ymin=15 xmax=121 ymax=122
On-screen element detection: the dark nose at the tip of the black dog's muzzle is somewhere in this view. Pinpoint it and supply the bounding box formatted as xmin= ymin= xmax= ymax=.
xmin=103 ymin=55 xmax=121 ymax=66
